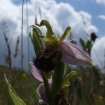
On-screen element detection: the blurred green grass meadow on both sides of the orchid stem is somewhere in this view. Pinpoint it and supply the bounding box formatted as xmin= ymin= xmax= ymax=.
xmin=0 ymin=65 xmax=105 ymax=105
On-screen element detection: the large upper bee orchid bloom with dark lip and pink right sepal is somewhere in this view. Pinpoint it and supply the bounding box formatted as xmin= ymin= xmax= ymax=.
xmin=35 ymin=20 xmax=92 ymax=72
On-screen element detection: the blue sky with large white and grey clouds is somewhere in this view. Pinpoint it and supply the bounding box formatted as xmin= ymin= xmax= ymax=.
xmin=0 ymin=0 xmax=105 ymax=71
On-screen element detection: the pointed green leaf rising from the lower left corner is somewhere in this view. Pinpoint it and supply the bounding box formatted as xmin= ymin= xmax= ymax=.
xmin=4 ymin=75 xmax=26 ymax=105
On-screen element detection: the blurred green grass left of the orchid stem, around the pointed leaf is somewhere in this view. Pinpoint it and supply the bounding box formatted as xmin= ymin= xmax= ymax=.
xmin=0 ymin=66 xmax=39 ymax=105
